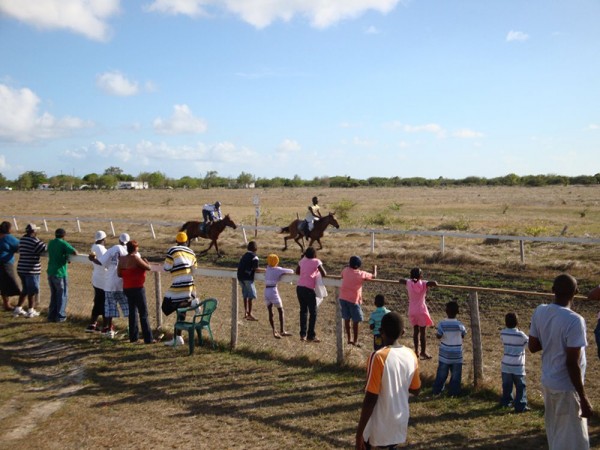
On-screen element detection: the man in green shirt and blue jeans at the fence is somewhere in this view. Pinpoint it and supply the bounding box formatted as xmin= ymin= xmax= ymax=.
xmin=46 ymin=228 xmax=77 ymax=322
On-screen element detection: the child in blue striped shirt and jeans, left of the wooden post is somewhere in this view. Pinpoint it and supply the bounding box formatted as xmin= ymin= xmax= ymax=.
xmin=433 ymin=301 xmax=467 ymax=397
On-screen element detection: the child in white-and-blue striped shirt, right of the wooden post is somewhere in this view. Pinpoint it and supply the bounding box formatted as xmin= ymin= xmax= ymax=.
xmin=500 ymin=312 xmax=529 ymax=413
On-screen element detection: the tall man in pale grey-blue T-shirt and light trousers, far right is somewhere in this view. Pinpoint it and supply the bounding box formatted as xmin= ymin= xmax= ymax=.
xmin=529 ymin=274 xmax=592 ymax=450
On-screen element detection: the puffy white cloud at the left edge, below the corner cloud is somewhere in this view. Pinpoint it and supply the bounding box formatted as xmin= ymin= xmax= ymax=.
xmin=0 ymin=84 xmax=92 ymax=142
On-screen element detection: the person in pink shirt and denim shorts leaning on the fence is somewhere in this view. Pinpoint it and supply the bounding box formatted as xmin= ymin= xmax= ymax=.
xmin=339 ymin=256 xmax=377 ymax=346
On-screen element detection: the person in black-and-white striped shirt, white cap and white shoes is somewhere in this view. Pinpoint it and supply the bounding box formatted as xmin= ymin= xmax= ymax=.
xmin=13 ymin=223 xmax=48 ymax=318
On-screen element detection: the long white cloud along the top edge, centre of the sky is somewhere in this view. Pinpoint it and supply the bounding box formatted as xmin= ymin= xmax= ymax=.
xmin=145 ymin=0 xmax=401 ymax=28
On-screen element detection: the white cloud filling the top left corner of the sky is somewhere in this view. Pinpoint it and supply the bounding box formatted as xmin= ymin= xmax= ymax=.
xmin=0 ymin=0 xmax=120 ymax=41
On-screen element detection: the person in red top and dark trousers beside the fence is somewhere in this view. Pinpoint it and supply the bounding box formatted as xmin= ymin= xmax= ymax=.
xmin=117 ymin=241 xmax=156 ymax=344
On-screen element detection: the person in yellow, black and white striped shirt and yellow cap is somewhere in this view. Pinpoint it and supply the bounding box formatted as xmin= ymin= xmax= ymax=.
xmin=161 ymin=231 xmax=200 ymax=347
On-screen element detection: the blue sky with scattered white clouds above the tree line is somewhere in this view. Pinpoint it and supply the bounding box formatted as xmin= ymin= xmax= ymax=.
xmin=0 ymin=0 xmax=600 ymax=179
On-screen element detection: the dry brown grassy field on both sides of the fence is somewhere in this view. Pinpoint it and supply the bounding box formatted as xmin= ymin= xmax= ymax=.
xmin=0 ymin=187 xmax=600 ymax=449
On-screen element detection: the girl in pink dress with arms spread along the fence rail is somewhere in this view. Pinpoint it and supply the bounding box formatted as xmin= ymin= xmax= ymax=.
xmin=400 ymin=267 xmax=438 ymax=359
